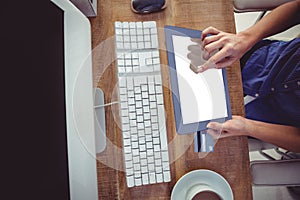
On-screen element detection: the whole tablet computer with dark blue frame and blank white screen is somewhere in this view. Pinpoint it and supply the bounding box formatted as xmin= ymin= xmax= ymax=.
xmin=164 ymin=26 xmax=231 ymax=134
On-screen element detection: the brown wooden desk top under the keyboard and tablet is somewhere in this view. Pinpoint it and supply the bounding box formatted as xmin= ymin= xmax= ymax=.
xmin=90 ymin=0 xmax=252 ymax=200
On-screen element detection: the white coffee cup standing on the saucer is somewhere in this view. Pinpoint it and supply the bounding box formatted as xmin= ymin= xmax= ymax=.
xmin=185 ymin=184 xmax=224 ymax=200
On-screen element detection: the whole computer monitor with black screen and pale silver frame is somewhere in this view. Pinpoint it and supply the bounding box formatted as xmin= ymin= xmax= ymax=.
xmin=0 ymin=0 xmax=98 ymax=200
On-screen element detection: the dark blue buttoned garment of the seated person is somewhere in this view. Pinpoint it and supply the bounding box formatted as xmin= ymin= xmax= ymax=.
xmin=242 ymin=38 xmax=300 ymax=127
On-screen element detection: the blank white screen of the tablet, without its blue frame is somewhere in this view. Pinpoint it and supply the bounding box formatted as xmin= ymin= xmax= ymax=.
xmin=172 ymin=35 xmax=228 ymax=124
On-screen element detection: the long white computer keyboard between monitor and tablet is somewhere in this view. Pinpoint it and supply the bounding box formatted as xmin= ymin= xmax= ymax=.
xmin=115 ymin=21 xmax=171 ymax=187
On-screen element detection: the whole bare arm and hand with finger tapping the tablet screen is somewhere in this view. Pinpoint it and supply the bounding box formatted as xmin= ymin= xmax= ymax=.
xmin=192 ymin=0 xmax=300 ymax=73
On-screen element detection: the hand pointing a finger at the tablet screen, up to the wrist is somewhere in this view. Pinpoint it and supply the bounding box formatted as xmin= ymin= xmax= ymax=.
xmin=190 ymin=27 xmax=252 ymax=72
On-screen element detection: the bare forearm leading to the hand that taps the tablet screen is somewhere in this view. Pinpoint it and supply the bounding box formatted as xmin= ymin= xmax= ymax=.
xmin=238 ymin=0 xmax=300 ymax=46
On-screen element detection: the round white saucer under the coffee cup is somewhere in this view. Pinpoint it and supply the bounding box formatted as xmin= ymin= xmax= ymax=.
xmin=171 ymin=169 xmax=233 ymax=200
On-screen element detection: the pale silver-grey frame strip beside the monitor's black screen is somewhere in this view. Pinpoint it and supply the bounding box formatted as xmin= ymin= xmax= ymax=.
xmin=51 ymin=0 xmax=98 ymax=200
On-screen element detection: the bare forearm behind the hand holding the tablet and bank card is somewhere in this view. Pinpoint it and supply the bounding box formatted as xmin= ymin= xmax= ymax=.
xmin=246 ymin=119 xmax=300 ymax=152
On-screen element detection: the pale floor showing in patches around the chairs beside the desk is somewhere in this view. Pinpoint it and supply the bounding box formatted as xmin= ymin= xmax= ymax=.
xmin=235 ymin=12 xmax=300 ymax=200
